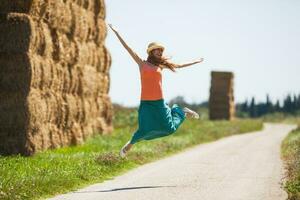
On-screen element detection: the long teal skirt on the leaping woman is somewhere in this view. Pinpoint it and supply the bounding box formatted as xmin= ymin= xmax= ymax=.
xmin=130 ymin=99 xmax=185 ymax=144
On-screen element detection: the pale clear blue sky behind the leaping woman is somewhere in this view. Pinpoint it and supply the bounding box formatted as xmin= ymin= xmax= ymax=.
xmin=105 ymin=0 xmax=300 ymax=106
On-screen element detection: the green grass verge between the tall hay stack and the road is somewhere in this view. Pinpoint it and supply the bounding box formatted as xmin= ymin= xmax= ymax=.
xmin=0 ymin=109 xmax=262 ymax=200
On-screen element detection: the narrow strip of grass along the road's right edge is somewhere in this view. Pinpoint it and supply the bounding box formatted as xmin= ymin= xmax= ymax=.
xmin=282 ymin=120 xmax=300 ymax=200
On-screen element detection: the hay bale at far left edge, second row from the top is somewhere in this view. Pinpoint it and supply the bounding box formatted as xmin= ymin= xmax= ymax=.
xmin=0 ymin=13 xmax=53 ymax=56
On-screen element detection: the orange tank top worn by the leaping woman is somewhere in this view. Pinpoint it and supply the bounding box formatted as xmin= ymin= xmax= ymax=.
xmin=140 ymin=62 xmax=163 ymax=100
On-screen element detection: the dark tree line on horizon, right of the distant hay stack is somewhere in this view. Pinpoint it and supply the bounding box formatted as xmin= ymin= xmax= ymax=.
xmin=236 ymin=94 xmax=300 ymax=118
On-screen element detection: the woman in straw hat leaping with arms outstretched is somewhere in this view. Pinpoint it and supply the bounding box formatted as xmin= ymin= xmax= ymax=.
xmin=109 ymin=25 xmax=203 ymax=157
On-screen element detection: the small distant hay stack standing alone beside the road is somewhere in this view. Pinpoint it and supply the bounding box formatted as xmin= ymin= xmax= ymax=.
xmin=209 ymin=72 xmax=235 ymax=120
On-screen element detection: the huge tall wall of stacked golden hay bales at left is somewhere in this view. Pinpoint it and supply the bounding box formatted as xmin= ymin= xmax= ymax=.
xmin=0 ymin=0 xmax=112 ymax=155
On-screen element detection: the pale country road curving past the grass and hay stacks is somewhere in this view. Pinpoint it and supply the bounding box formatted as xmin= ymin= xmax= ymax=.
xmin=49 ymin=124 xmax=295 ymax=200
